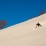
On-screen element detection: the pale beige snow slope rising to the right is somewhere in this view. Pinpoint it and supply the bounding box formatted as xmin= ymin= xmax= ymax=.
xmin=0 ymin=13 xmax=46 ymax=46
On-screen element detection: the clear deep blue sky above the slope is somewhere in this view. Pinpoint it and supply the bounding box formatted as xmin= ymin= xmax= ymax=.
xmin=0 ymin=0 xmax=46 ymax=27
